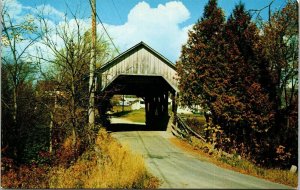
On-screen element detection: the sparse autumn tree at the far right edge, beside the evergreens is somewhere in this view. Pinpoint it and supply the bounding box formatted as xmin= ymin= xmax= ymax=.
xmin=261 ymin=0 xmax=299 ymax=164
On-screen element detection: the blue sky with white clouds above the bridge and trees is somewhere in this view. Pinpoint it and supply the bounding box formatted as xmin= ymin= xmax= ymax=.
xmin=4 ymin=0 xmax=285 ymax=62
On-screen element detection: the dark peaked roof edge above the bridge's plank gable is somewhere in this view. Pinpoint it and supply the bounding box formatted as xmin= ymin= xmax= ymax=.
xmin=98 ymin=41 xmax=176 ymax=72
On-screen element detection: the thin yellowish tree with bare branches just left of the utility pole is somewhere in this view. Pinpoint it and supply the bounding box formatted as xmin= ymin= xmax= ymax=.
xmin=38 ymin=8 xmax=109 ymax=157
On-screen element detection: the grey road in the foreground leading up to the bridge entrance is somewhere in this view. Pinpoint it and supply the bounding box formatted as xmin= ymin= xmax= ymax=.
xmin=112 ymin=131 xmax=290 ymax=189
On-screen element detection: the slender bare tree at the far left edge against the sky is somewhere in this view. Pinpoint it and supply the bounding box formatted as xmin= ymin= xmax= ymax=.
xmin=1 ymin=5 xmax=40 ymax=124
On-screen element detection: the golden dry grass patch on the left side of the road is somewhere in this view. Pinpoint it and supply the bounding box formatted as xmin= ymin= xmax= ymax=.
xmin=50 ymin=127 xmax=159 ymax=188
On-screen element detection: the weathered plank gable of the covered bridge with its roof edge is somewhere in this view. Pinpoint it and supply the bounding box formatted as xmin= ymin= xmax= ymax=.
xmin=98 ymin=42 xmax=178 ymax=91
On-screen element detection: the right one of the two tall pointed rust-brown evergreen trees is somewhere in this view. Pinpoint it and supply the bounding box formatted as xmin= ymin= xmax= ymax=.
xmin=219 ymin=4 xmax=274 ymax=159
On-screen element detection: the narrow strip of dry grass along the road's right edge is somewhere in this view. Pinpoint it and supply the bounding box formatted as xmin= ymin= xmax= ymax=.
xmin=171 ymin=138 xmax=298 ymax=187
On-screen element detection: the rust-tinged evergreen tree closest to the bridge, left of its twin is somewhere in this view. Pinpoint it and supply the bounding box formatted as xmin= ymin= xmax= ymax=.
xmin=176 ymin=0 xmax=225 ymax=107
